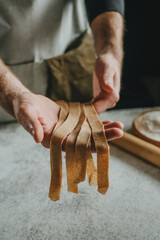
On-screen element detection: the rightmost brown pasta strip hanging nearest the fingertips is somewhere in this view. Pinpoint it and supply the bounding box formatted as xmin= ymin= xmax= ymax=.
xmin=84 ymin=103 xmax=109 ymax=194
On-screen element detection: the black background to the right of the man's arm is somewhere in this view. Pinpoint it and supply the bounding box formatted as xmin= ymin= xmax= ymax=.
xmin=116 ymin=0 xmax=160 ymax=108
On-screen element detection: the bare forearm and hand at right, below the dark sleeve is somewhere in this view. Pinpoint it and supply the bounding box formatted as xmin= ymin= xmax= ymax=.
xmin=91 ymin=12 xmax=124 ymax=113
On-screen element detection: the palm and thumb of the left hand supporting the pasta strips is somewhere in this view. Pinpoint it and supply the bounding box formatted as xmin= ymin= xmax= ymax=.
xmin=13 ymin=92 xmax=60 ymax=148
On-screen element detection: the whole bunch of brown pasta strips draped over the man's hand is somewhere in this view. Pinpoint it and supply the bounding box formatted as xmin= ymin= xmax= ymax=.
xmin=49 ymin=101 xmax=109 ymax=201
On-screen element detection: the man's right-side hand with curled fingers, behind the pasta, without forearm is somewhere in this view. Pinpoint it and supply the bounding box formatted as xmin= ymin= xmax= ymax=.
xmin=93 ymin=53 xmax=120 ymax=113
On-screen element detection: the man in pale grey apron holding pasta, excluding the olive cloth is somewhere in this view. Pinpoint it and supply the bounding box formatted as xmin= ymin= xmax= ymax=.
xmin=0 ymin=0 xmax=124 ymax=147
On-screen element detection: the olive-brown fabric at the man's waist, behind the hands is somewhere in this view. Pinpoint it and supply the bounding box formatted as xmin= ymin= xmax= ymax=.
xmin=46 ymin=33 xmax=95 ymax=102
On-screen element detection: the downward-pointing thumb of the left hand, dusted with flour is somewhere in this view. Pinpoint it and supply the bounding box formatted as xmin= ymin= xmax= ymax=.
xmin=18 ymin=106 xmax=44 ymax=143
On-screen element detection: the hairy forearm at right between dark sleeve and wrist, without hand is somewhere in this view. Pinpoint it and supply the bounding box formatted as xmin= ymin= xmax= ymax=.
xmin=91 ymin=12 xmax=124 ymax=64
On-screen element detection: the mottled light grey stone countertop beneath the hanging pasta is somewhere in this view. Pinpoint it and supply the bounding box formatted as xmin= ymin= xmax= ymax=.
xmin=0 ymin=109 xmax=160 ymax=240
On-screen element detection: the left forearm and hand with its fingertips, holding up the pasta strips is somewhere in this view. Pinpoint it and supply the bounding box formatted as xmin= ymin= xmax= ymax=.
xmin=0 ymin=60 xmax=123 ymax=151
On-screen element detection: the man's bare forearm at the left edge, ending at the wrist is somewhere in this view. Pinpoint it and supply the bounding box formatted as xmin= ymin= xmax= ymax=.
xmin=0 ymin=59 xmax=29 ymax=116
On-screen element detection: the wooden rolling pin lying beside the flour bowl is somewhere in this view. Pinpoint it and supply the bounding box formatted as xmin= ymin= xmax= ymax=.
xmin=112 ymin=132 xmax=160 ymax=167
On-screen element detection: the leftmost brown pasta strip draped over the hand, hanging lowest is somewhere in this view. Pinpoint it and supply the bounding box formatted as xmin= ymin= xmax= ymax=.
xmin=49 ymin=103 xmax=79 ymax=201
